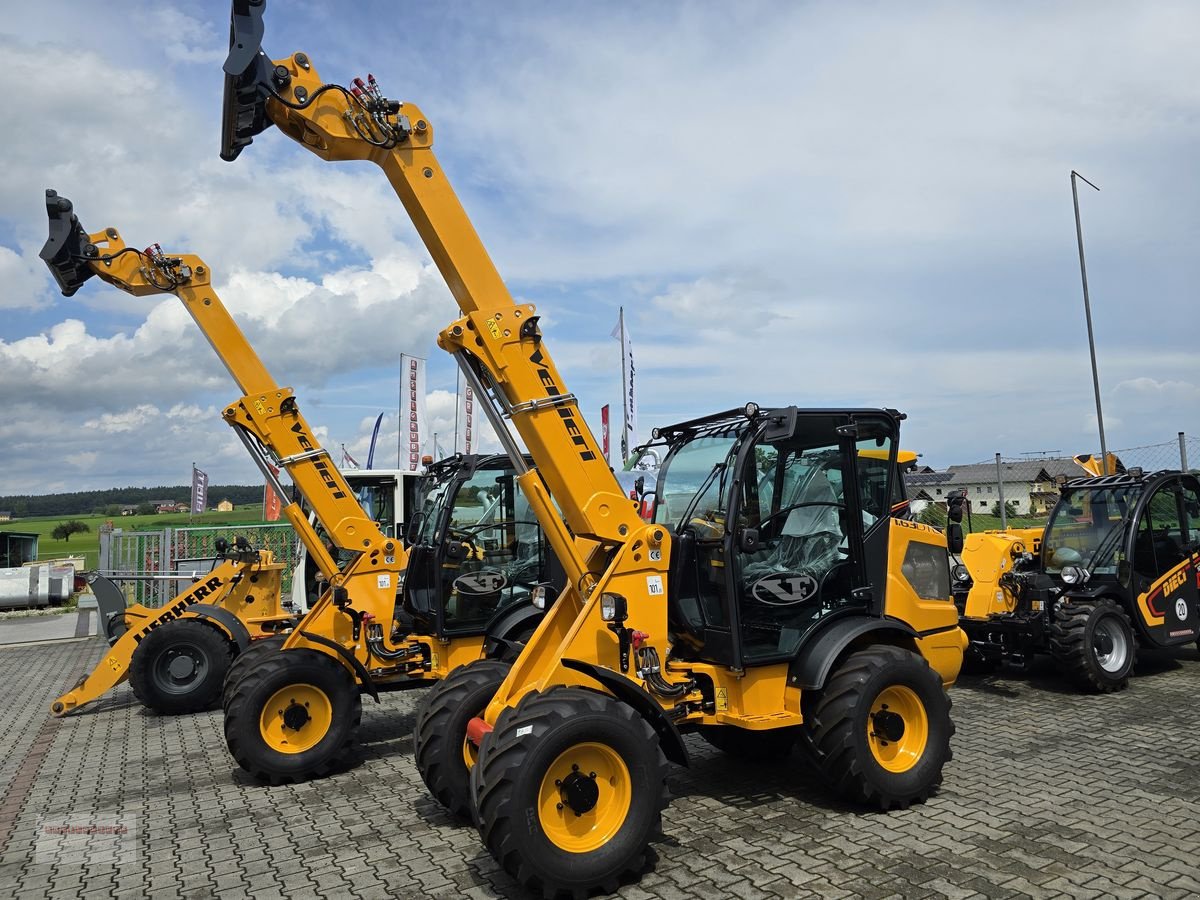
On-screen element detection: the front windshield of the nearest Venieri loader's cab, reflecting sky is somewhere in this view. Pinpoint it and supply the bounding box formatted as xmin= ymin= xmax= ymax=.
xmin=654 ymin=434 xmax=737 ymax=529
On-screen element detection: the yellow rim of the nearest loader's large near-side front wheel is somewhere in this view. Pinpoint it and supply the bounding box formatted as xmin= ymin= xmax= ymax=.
xmin=538 ymin=743 xmax=634 ymax=853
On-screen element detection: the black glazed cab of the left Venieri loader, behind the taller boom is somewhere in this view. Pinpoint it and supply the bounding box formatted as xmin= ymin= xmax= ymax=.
xmin=404 ymin=454 xmax=563 ymax=637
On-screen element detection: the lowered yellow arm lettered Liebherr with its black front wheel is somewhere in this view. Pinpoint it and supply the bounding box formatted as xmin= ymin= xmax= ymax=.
xmin=50 ymin=538 xmax=299 ymax=716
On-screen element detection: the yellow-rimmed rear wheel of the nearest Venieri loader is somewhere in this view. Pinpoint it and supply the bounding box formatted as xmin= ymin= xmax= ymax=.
xmin=806 ymin=646 xmax=954 ymax=810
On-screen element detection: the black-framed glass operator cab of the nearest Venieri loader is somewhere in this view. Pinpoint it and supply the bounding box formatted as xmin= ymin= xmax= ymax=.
xmin=655 ymin=404 xmax=931 ymax=668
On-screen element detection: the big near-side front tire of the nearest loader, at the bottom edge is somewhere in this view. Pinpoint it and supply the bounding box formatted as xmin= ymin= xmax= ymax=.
xmin=472 ymin=686 xmax=667 ymax=900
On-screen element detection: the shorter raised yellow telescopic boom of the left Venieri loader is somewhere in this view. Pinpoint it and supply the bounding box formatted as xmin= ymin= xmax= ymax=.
xmin=42 ymin=191 xmax=407 ymax=690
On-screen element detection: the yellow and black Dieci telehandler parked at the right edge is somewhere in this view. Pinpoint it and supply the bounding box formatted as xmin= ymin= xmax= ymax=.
xmin=952 ymin=467 xmax=1200 ymax=692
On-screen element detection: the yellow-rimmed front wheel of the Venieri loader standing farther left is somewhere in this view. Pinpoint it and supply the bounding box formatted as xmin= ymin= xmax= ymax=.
xmin=224 ymin=649 xmax=362 ymax=785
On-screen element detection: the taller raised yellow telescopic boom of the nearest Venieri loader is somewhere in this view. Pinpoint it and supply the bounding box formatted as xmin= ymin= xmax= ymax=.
xmin=221 ymin=0 xmax=672 ymax=720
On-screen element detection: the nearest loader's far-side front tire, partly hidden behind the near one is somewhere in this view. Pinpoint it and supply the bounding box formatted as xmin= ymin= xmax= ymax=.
xmin=413 ymin=659 xmax=512 ymax=821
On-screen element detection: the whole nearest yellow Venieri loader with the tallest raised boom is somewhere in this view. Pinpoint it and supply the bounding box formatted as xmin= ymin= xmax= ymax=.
xmin=221 ymin=0 xmax=966 ymax=896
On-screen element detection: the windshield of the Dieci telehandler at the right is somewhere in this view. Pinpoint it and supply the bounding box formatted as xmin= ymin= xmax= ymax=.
xmin=1042 ymin=485 xmax=1141 ymax=575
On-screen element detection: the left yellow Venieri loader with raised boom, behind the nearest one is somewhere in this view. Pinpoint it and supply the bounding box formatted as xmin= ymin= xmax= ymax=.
xmin=43 ymin=191 xmax=558 ymax=782
